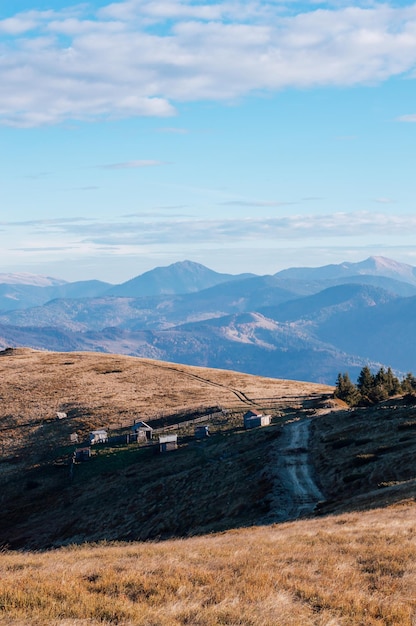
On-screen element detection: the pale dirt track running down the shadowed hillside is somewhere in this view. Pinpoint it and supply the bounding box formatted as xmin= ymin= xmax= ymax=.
xmin=267 ymin=418 xmax=325 ymax=522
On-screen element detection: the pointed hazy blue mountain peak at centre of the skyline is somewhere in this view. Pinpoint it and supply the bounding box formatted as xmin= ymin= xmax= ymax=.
xmin=107 ymin=261 xmax=251 ymax=298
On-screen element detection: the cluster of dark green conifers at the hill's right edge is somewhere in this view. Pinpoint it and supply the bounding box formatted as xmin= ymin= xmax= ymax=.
xmin=334 ymin=365 xmax=416 ymax=406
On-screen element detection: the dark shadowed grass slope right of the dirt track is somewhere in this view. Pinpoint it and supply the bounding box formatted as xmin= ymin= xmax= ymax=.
xmin=310 ymin=398 xmax=416 ymax=512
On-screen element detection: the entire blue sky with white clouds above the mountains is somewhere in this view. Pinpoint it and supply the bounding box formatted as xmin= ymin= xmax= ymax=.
xmin=0 ymin=0 xmax=416 ymax=283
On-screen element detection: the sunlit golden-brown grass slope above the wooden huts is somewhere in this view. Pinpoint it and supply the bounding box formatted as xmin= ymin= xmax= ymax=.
xmin=0 ymin=348 xmax=332 ymax=443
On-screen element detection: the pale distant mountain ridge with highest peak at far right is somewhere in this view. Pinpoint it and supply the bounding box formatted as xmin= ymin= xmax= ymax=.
xmin=275 ymin=256 xmax=416 ymax=285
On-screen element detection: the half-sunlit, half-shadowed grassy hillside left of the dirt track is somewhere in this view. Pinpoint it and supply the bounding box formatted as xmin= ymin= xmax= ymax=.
xmin=0 ymin=350 xmax=331 ymax=549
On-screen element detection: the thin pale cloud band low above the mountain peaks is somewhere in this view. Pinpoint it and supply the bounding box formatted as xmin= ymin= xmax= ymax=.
xmin=4 ymin=211 xmax=416 ymax=246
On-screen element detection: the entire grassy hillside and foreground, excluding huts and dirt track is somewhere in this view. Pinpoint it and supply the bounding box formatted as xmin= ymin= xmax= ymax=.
xmin=0 ymin=349 xmax=416 ymax=626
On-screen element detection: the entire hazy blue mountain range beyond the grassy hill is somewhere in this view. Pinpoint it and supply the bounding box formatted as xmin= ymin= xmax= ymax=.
xmin=0 ymin=252 xmax=416 ymax=384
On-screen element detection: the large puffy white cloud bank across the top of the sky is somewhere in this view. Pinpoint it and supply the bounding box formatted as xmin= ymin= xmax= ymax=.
xmin=0 ymin=0 xmax=416 ymax=127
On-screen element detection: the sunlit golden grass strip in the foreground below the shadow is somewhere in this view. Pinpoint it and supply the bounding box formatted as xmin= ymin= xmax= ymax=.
xmin=0 ymin=502 xmax=416 ymax=626
